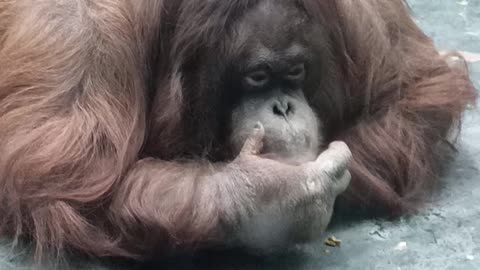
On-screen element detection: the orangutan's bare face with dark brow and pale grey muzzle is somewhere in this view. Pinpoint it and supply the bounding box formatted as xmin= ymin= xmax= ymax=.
xmin=225 ymin=1 xmax=323 ymax=163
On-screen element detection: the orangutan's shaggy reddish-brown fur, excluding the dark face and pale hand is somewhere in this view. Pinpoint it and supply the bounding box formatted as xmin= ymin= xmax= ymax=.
xmin=0 ymin=0 xmax=475 ymax=258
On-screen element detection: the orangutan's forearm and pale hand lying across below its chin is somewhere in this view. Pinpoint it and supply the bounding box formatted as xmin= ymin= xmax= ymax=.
xmin=111 ymin=128 xmax=351 ymax=254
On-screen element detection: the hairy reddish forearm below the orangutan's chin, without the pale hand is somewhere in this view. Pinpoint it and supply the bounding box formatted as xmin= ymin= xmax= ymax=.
xmin=110 ymin=159 xmax=228 ymax=251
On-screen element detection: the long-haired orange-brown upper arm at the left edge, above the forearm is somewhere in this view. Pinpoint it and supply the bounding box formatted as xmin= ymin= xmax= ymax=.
xmin=0 ymin=0 xmax=161 ymax=257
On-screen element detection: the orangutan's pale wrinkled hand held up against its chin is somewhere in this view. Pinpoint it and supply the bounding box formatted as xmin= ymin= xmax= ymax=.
xmin=227 ymin=124 xmax=351 ymax=252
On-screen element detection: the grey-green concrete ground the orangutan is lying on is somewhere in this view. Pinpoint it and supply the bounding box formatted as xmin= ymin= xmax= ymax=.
xmin=0 ymin=0 xmax=480 ymax=270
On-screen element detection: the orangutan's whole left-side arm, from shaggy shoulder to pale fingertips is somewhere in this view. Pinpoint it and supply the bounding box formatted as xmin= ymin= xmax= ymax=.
xmin=0 ymin=0 xmax=350 ymax=258
